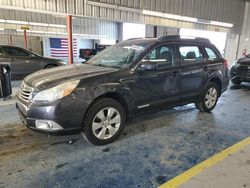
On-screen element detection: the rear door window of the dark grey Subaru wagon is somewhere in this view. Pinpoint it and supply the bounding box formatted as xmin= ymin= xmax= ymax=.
xmin=179 ymin=46 xmax=203 ymax=64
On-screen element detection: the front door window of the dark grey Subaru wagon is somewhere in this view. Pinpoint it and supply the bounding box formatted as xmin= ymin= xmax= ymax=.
xmin=144 ymin=45 xmax=174 ymax=68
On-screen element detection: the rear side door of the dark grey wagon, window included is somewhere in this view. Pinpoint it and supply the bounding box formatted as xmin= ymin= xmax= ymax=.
xmin=177 ymin=44 xmax=208 ymax=101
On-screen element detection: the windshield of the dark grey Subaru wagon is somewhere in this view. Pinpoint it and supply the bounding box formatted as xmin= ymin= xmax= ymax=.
xmin=86 ymin=41 xmax=149 ymax=68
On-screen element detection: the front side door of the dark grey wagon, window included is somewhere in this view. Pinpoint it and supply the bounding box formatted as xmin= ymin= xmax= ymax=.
xmin=124 ymin=44 xmax=180 ymax=109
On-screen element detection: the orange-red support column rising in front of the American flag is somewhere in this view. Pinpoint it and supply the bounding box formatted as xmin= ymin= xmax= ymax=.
xmin=66 ymin=15 xmax=73 ymax=64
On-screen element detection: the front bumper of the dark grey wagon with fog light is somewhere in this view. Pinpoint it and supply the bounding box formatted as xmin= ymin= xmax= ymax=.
xmin=16 ymin=97 xmax=85 ymax=135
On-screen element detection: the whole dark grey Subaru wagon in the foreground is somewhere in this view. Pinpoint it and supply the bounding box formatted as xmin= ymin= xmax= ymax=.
xmin=17 ymin=36 xmax=229 ymax=145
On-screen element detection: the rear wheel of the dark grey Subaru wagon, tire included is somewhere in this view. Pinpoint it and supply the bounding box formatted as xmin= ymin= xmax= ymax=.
xmin=195 ymin=82 xmax=219 ymax=112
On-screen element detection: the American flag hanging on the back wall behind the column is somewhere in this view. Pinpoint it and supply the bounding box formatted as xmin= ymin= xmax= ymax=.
xmin=50 ymin=38 xmax=77 ymax=58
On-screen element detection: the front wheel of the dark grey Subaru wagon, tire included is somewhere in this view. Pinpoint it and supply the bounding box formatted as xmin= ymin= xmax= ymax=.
xmin=82 ymin=98 xmax=126 ymax=145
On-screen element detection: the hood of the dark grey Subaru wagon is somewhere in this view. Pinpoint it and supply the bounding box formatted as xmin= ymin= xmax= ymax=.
xmin=24 ymin=64 xmax=118 ymax=90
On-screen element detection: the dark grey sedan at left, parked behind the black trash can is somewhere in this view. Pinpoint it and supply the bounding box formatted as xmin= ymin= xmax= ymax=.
xmin=0 ymin=45 xmax=65 ymax=79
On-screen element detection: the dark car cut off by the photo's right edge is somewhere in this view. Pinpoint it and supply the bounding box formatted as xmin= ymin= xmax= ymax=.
xmin=230 ymin=54 xmax=250 ymax=85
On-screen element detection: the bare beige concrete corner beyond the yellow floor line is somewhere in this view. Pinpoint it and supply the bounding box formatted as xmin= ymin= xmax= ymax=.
xmin=180 ymin=145 xmax=250 ymax=188
